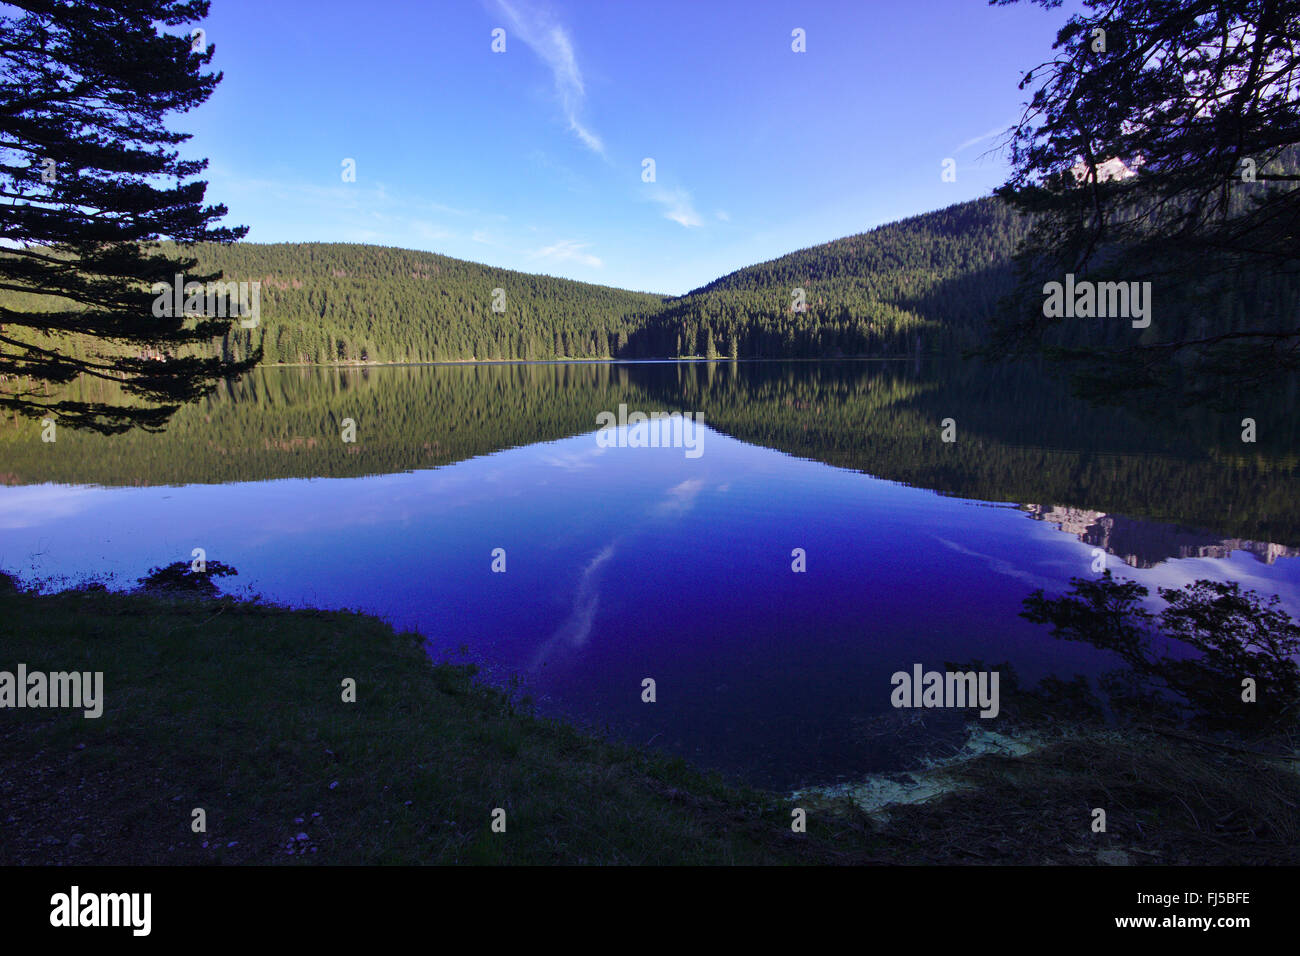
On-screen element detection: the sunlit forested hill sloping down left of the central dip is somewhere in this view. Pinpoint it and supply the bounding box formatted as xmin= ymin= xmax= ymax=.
xmin=183 ymin=242 xmax=663 ymax=363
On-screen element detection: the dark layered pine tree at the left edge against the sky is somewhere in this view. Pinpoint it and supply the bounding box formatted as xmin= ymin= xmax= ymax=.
xmin=0 ymin=0 xmax=257 ymax=433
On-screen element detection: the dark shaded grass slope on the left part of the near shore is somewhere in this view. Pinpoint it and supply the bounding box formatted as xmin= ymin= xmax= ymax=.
xmin=0 ymin=589 xmax=868 ymax=864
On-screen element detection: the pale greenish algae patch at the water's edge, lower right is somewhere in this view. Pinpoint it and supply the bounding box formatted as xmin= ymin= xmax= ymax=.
xmin=790 ymin=724 xmax=1047 ymax=816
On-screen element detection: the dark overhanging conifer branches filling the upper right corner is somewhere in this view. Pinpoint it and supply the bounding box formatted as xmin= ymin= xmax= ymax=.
xmin=985 ymin=0 xmax=1300 ymax=407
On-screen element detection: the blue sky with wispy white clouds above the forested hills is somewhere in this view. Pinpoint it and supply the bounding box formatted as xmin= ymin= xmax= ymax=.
xmin=185 ymin=0 xmax=1066 ymax=294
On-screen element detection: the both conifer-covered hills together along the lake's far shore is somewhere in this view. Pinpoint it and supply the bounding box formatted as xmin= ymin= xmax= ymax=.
xmin=0 ymin=198 xmax=1024 ymax=364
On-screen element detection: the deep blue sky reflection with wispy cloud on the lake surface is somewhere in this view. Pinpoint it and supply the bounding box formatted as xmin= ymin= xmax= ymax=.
xmin=0 ymin=429 xmax=1300 ymax=786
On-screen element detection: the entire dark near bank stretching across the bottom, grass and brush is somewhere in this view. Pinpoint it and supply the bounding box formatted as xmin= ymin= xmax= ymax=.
xmin=0 ymin=578 xmax=1300 ymax=864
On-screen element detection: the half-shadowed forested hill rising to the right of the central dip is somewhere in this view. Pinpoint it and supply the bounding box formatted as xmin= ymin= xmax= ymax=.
xmin=633 ymin=198 xmax=1027 ymax=358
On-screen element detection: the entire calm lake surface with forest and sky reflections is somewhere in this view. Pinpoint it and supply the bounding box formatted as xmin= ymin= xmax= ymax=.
xmin=0 ymin=362 xmax=1300 ymax=788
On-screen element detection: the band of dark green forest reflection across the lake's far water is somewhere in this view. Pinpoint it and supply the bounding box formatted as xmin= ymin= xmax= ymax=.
xmin=0 ymin=360 xmax=1300 ymax=548
